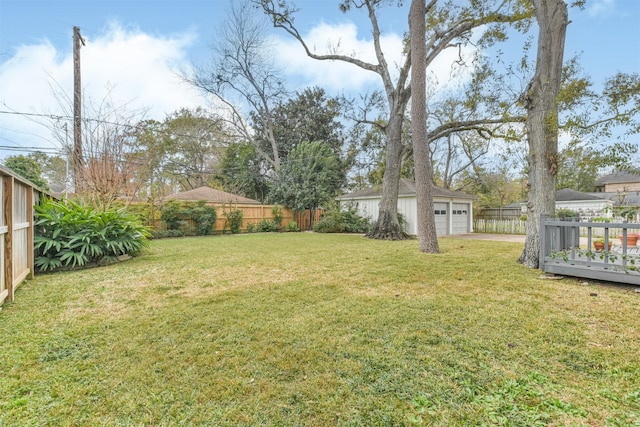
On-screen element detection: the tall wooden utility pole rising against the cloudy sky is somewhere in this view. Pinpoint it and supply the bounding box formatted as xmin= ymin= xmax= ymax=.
xmin=73 ymin=27 xmax=84 ymax=193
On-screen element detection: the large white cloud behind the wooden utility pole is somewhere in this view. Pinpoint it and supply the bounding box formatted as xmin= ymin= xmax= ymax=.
xmin=0 ymin=23 xmax=206 ymax=155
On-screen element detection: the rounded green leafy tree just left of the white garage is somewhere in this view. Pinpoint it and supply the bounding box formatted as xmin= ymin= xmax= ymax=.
xmin=269 ymin=141 xmax=344 ymax=227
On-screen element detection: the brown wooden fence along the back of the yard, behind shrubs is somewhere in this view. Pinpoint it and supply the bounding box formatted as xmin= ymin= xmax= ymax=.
xmin=151 ymin=201 xmax=322 ymax=234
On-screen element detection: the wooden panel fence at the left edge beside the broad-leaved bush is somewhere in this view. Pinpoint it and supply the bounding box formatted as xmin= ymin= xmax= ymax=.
xmin=0 ymin=167 xmax=41 ymax=305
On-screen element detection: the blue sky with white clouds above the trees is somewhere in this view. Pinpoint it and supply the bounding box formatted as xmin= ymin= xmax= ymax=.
xmin=0 ymin=0 xmax=640 ymax=159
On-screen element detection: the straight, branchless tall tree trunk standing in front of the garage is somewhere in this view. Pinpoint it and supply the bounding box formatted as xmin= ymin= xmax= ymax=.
xmin=409 ymin=0 xmax=440 ymax=253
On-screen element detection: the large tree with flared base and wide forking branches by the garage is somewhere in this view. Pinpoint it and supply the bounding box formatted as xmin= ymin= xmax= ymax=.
xmin=253 ymin=0 xmax=527 ymax=239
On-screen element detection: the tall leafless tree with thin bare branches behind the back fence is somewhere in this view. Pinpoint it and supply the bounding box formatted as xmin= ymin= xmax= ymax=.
xmin=185 ymin=0 xmax=287 ymax=172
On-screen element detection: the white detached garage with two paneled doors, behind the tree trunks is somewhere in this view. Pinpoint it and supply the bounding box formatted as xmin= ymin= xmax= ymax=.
xmin=336 ymin=179 xmax=474 ymax=236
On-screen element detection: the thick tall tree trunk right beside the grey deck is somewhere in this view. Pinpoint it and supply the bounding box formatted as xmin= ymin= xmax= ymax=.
xmin=519 ymin=0 xmax=568 ymax=268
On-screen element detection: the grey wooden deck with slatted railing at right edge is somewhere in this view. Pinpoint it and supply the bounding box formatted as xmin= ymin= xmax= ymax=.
xmin=540 ymin=216 xmax=640 ymax=285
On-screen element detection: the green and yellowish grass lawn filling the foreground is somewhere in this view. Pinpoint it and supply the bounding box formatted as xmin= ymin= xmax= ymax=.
xmin=0 ymin=233 xmax=640 ymax=426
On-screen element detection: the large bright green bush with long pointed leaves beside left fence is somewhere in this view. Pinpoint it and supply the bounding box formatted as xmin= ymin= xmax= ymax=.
xmin=34 ymin=199 xmax=150 ymax=271
